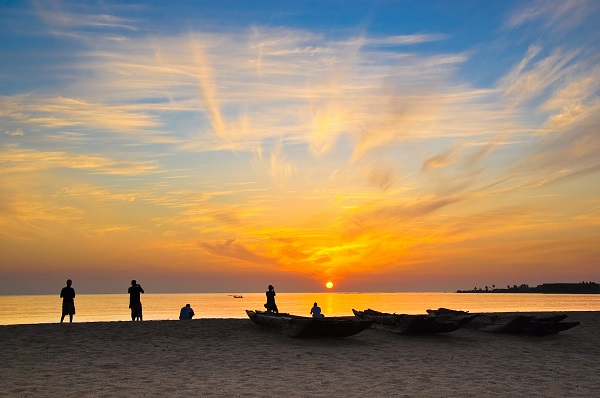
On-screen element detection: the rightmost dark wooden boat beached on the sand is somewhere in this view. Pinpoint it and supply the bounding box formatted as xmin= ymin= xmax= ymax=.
xmin=427 ymin=308 xmax=579 ymax=336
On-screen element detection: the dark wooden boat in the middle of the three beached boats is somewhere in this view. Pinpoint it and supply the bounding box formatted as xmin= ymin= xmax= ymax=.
xmin=352 ymin=309 xmax=477 ymax=334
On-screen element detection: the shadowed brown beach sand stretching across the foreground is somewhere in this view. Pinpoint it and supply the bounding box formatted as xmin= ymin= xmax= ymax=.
xmin=0 ymin=312 xmax=600 ymax=397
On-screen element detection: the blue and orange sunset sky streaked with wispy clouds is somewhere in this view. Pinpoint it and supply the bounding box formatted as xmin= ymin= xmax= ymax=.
xmin=0 ymin=0 xmax=600 ymax=294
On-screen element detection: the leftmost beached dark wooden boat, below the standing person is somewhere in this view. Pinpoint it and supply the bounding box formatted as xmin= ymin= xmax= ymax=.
xmin=246 ymin=310 xmax=374 ymax=337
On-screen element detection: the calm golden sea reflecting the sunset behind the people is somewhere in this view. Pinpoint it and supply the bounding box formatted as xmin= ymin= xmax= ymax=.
xmin=0 ymin=293 xmax=600 ymax=325
